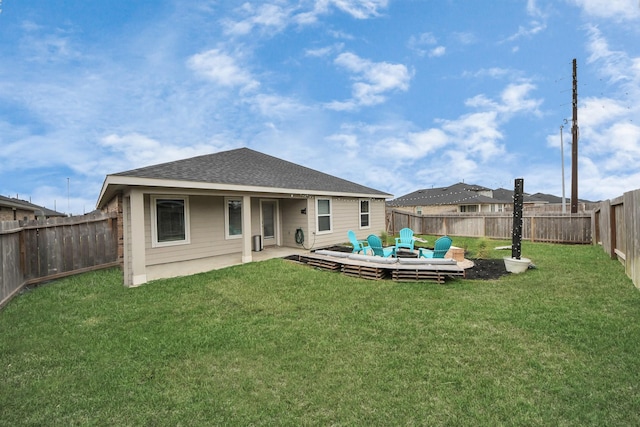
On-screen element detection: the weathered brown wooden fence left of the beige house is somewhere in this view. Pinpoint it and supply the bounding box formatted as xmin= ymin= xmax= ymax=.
xmin=0 ymin=213 xmax=119 ymax=307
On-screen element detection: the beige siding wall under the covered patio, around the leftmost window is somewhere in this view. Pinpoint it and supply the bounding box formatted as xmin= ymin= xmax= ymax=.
xmin=144 ymin=195 xmax=244 ymax=265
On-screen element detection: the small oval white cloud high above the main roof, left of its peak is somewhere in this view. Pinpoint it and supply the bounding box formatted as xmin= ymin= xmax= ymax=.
xmin=187 ymin=49 xmax=260 ymax=90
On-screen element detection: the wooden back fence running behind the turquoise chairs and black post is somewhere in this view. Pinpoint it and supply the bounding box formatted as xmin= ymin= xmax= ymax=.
xmin=387 ymin=210 xmax=592 ymax=244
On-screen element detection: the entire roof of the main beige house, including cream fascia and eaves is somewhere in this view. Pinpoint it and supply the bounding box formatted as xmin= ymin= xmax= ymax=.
xmin=98 ymin=148 xmax=392 ymax=206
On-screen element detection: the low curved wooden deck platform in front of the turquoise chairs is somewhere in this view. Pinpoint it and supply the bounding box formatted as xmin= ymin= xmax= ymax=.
xmin=297 ymin=252 xmax=465 ymax=283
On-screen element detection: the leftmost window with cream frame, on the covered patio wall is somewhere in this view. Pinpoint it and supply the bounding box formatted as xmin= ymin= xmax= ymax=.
xmin=151 ymin=197 xmax=189 ymax=247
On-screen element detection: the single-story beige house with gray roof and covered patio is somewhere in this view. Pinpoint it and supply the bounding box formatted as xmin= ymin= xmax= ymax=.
xmin=97 ymin=148 xmax=392 ymax=286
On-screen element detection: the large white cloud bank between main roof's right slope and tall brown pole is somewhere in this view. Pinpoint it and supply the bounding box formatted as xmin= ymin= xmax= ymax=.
xmin=324 ymin=75 xmax=540 ymax=194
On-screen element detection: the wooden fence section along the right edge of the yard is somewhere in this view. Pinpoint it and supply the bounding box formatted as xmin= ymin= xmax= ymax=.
xmin=594 ymin=190 xmax=640 ymax=288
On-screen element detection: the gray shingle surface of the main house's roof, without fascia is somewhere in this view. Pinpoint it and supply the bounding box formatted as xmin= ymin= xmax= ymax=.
xmin=113 ymin=148 xmax=389 ymax=197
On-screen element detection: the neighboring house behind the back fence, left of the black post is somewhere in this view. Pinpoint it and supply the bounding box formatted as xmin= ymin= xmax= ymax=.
xmin=387 ymin=182 xmax=513 ymax=215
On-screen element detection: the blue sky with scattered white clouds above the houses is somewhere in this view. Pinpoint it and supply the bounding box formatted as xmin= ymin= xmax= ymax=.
xmin=0 ymin=0 xmax=640 ymax=214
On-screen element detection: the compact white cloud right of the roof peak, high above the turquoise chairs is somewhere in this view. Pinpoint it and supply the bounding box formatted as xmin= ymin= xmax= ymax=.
xmin=327 ymin=52 xmax=411 ymax=110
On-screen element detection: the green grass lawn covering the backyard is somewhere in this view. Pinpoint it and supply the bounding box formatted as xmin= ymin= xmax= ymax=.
xmin=0 ymin=238 xmax=640 ymax=426
